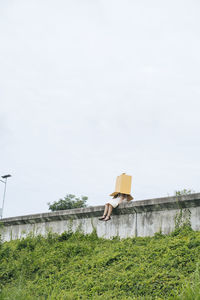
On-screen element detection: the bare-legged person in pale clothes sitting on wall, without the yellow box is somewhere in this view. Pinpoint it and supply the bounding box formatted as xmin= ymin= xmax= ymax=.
xmin=99 ymin=193 xmax=133 ymax=221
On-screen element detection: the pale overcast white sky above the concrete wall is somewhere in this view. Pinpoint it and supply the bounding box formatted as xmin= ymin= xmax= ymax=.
xmin=0 ymin=0 xmax=200 ymax=217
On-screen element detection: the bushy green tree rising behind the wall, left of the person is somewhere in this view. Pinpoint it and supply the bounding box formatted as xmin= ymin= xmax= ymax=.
xmin=47 ymin=194 xmax=88 ymax=211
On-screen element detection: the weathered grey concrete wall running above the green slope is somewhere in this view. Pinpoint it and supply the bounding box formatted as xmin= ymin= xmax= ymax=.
xmin=0 ymin=193 xmax=200 ymax=241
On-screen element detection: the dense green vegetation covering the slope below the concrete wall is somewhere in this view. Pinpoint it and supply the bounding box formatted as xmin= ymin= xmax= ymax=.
xmin=0 ymin=225 xmax=200 ymax=300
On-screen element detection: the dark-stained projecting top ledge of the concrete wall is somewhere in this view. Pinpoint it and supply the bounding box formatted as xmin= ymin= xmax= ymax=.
xmin=0 ymin=193 xmax=200 ymax=226
